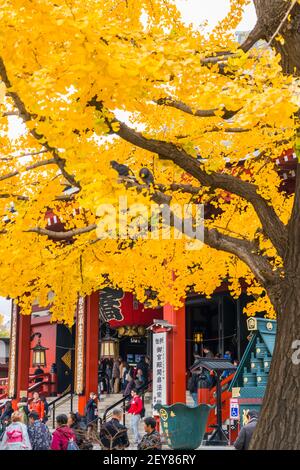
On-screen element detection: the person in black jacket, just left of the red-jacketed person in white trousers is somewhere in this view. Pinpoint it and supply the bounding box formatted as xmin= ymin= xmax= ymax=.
xmin=99 ymin=408 xmax=129 ymax=450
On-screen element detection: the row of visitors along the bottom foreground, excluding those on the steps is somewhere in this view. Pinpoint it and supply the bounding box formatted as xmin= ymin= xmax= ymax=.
xmin=0 ymin=390 xmax=161 ymax=450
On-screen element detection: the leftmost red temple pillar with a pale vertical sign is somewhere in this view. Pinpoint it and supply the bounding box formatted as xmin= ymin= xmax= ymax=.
xmin=8 ymin=303 xmax=31 ymax=408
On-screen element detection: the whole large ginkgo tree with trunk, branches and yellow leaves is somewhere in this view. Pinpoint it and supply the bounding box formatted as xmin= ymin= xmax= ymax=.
xmin=0 ymin=0 xmax=300 ymax=449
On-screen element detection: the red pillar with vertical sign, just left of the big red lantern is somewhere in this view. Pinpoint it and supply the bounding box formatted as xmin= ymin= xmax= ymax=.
xmin=75 ymin=292 xmax=99 ymax=414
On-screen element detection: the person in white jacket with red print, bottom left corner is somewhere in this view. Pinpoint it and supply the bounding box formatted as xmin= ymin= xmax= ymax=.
xmin=0 ymin=411 xmax=31 ymax=450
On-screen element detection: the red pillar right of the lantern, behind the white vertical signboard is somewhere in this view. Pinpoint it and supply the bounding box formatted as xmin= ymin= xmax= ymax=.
xmin=164 ymin=305 xmax=186 ymax=404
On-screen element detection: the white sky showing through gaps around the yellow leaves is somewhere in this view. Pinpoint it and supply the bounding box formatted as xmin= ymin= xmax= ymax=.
xmin=0 ymin=0 xmax=256 ymax=319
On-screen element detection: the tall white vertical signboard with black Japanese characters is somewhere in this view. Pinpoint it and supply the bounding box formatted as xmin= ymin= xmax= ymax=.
xmin=153 ymin=332 xmax=167 ymax=407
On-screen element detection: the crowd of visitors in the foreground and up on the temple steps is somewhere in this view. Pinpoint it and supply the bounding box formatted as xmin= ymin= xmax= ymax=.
xmin=0 ymin=357 xmax=161 ymax=450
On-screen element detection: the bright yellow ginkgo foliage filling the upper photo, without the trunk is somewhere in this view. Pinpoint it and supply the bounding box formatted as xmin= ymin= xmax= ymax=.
xmin=0 ymin=0 xmax=296 ymax=324
